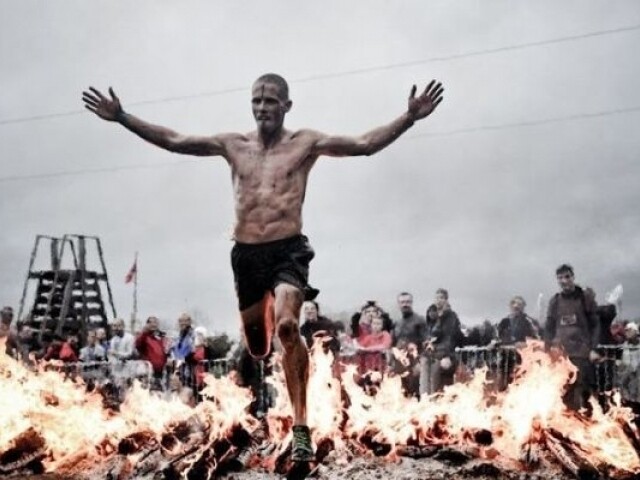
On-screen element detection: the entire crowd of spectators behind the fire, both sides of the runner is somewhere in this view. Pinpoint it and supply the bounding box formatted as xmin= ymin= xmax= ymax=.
xmin=0 ymin=265 xmax=640 ymax=414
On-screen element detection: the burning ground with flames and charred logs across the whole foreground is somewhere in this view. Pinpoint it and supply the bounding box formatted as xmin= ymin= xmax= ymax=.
xmin=0 ymin=343 xmax=640 ymax=479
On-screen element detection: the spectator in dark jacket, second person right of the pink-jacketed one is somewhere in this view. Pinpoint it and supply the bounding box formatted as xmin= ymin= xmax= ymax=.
xmin=420 ymin=288 xmax=463 ymax=395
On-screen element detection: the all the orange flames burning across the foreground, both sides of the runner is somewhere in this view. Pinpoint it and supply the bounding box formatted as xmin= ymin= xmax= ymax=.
xmin=0 ymin=342 xmax=640 ymax=478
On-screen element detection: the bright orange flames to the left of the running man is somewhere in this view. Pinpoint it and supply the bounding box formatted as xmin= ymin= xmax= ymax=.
xmin=0 ymin=344 xmax=256 ymax=471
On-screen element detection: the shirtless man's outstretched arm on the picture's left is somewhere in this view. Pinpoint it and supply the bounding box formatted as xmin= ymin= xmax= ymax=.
xmin=82 ymin=87 xmax=225 ymax=156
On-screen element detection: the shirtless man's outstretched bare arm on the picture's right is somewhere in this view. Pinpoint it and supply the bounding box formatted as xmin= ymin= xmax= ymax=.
xmin=313 ymin=80 xmax=444 ymax=157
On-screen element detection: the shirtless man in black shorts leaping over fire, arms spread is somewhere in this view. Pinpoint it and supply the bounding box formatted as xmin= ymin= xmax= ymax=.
xmin=82 ymin=74 xmax=444 ymax=462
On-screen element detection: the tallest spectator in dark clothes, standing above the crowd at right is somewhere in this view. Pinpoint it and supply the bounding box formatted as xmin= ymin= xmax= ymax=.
xmin=545 ymin=264 xmax=600 ymax=410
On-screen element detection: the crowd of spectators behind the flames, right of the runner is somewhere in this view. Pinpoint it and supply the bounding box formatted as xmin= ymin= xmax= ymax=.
xmin=294 ymin=265 xmax=640 ymax=409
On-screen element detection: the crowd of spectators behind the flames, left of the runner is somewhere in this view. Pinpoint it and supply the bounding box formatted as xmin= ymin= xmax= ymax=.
xmin=0 ymin=307 xmax=226 ymax=403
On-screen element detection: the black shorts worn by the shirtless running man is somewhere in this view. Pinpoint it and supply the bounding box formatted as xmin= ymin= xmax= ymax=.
xmin=231 ymin=235 xmax=319 ymax=311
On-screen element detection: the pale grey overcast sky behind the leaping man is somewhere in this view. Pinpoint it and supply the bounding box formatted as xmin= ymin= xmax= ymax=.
xmin=0 ymin=0 xmax=640 ymax=333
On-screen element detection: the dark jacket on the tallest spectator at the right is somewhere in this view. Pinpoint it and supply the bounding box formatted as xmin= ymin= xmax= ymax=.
xmin=545 ymin=286 xmax=600 ymax=358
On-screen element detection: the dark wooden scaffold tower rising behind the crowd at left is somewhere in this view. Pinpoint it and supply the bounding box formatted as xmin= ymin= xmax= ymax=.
xmin=18 ymin=235 xmax=117 ymax=340
